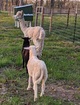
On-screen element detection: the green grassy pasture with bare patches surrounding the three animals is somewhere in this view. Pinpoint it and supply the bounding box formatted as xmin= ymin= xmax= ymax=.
xmin=0 ymin=12 xmax=80 ymax=105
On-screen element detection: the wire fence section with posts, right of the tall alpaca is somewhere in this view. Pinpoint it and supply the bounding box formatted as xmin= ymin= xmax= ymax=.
xmin=43 ymin=9 xmax=80 ymax=42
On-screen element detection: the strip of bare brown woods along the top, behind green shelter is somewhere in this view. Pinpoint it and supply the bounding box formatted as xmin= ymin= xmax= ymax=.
xmin=0 ymin=0 xmax=79 ymax=11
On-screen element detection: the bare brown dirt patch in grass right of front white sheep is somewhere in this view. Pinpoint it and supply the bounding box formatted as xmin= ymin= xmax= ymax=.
xmin=46 ymin=83 xmax=80 ymax=105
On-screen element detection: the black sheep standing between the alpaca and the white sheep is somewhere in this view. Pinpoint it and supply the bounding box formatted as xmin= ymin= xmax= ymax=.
xmin=22 ymin=37 xmax=30 ymax=73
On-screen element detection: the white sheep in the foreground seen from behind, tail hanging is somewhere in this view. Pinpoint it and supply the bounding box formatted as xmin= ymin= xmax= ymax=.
xmin=25 ymin=46 xmax=48 ymax=101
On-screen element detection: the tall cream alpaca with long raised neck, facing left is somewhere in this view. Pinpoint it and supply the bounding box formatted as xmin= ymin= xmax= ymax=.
xmin=15 ymin=11 xmax=45 ymax=57
